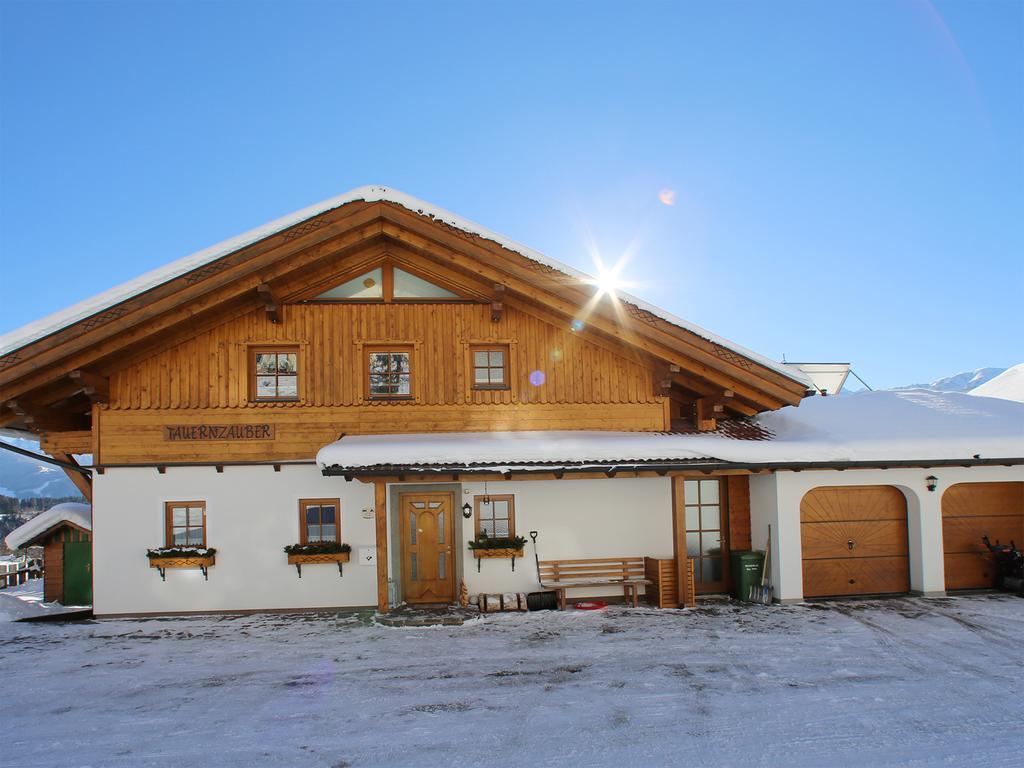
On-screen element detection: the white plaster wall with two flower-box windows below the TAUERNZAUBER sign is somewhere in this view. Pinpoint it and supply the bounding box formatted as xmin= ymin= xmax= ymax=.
xmin=93 ymin=465 xmax=377 ymax=615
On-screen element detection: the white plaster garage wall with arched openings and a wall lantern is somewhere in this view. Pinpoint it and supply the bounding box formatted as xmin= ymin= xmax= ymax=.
xmin=751 ymin=466 xmax=1024 ymax=602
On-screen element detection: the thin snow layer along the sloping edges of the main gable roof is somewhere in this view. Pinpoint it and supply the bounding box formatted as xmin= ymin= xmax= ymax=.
xmin=0 ymin=185 xmax=811 ymax=386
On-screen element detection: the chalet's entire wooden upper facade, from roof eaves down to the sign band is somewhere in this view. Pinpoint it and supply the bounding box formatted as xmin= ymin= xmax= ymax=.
xmin=0 ymin=195 xmax=806 ymax=475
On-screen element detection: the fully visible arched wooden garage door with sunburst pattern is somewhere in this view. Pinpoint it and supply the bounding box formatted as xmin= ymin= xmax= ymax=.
xmin=800 ymin=485 xmax=910 ymax=597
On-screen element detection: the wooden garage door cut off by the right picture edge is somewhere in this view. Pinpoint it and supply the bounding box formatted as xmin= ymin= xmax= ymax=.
xmin=942 ymin=482 xmax=1024 ymax=590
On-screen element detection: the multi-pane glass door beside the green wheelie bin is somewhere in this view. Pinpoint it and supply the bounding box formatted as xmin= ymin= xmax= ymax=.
xmin=683 ymin=479 xmax=729 ymax=592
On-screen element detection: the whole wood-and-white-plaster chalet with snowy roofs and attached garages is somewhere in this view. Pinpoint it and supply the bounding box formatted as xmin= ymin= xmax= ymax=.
xmin=0 ymin=187 xmax=1024 ymax=615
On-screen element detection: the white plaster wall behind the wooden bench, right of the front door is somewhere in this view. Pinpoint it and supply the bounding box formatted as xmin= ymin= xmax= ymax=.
xmin=457 ymin=477 xmax=672 ymax=597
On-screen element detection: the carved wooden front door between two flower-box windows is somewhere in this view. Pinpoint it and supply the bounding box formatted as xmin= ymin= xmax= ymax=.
xmin=398 ymin=494 xmax=455 ymax=603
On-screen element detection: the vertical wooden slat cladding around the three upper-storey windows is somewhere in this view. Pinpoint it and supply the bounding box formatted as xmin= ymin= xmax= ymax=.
xmin=110 ymin=304 xmax=658 ymax=410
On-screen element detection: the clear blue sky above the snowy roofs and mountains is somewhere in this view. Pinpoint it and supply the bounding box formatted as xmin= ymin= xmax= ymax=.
xmin=0 ymin=0 xmax=1024 ymax=386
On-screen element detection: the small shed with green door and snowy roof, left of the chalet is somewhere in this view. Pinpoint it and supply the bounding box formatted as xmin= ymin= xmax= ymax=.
xmin=5 ymin=502 xmax=92 ymax=605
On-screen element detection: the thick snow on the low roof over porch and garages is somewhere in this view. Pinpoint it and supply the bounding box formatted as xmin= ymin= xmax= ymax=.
xmin=316 ymin=390 xmax=1024 ymax=473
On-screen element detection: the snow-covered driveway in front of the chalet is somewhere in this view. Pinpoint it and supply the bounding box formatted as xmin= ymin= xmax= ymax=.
xmin=0 ymin=595 xmax=1024 ymax=767
